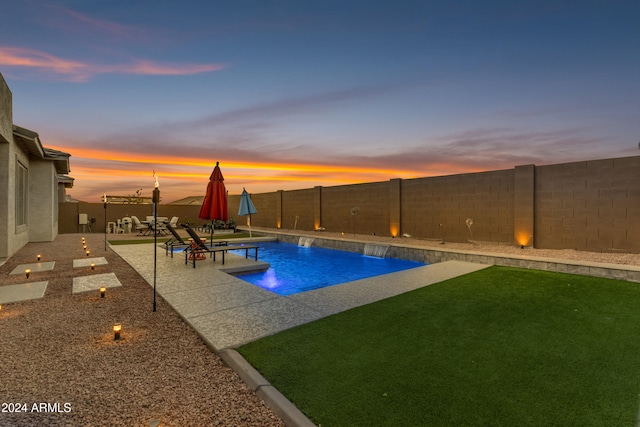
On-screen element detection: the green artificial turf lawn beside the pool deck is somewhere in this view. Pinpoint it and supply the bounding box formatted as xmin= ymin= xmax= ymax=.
xmin=238 ymin=266 xmax=640 ymax=427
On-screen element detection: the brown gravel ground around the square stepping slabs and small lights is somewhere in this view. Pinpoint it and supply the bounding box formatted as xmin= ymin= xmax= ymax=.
xmin=0 ymin=234 xmax=283 ymax=427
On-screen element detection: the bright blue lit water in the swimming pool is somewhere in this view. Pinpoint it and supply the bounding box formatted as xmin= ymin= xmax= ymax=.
xmin=230 ymin=242 xmax=425 ymax=296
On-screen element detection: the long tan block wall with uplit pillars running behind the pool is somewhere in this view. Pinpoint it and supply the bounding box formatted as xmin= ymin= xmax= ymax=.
xmin=61 ymin=156 xmax=640 ymax=253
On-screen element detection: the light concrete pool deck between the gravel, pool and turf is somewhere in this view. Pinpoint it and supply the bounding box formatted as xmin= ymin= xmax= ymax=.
xmin=111 ymin=243 xmax=488 ymax=352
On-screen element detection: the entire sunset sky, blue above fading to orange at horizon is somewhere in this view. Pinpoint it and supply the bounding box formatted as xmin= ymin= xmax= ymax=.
xmin=0 ymin=0 xmax=640 ymax=202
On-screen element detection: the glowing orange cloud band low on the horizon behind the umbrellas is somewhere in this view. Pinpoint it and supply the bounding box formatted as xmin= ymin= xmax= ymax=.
xmin=58 ymin=147 xmax=430 ymax=201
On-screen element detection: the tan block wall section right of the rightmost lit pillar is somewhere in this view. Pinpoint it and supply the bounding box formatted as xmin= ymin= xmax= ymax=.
xmin=535 ymin=156 xmax=640 ymax=252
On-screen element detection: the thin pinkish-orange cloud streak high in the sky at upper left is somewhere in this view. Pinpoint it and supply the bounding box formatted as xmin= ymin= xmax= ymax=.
xmin=0 ymin=46 xmax=224 ymax=82
